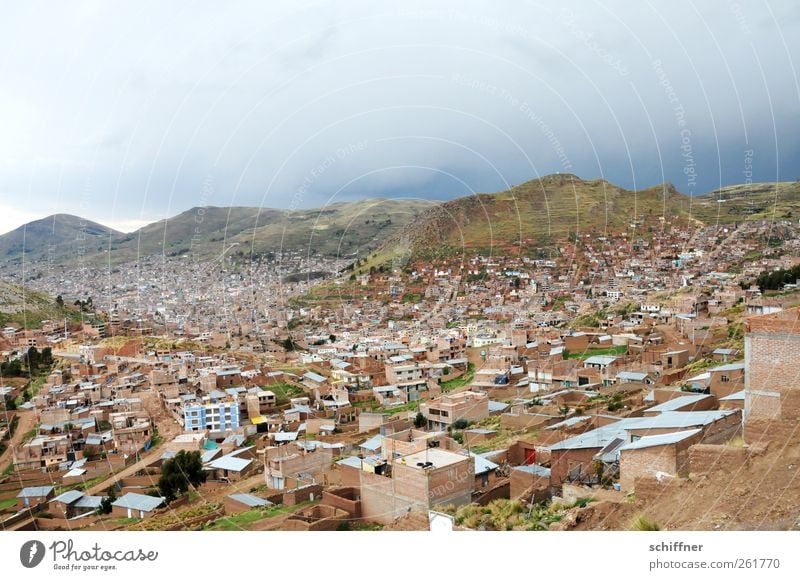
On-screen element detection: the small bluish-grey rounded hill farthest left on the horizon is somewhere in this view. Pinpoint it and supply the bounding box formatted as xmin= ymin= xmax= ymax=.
xmin=0 ymin=214 xmax=124 ymax=263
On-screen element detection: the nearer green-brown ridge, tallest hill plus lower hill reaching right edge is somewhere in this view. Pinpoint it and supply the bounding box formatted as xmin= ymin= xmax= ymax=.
xmin=362 ymin=174 xmax=800 ymax=269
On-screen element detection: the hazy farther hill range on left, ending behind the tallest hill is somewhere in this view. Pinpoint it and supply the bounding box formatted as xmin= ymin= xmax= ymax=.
xmin=0 ymin=199 xmax=436 ymax=265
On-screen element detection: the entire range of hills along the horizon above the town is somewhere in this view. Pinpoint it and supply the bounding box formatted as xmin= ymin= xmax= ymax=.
xmin=6 ymin=174 xmax=800 ymax=268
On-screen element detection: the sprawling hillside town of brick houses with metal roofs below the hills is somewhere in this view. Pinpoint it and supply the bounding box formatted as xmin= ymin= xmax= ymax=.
xmin=0 ymin=218 xmax=800 ymax=530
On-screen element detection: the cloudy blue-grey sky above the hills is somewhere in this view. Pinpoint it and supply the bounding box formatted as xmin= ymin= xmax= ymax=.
xmin=0 ymin=0 xmax=800 ymax=232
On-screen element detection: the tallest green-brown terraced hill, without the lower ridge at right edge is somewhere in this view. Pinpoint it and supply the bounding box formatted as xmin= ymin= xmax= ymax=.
xmin=371 ymin=174 xmax=689 ymax=262
